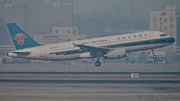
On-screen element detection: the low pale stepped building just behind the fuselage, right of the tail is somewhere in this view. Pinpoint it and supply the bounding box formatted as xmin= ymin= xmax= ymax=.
xmin=33 ymin=27 xmax=86 ymax=44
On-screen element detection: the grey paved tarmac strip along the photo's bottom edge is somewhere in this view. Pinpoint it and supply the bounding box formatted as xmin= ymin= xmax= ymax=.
xmin=0 ymin=83 xmax=180 ymax=101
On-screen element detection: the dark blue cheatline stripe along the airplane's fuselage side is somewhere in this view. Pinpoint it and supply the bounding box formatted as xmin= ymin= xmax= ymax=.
xmin=51 ymin=37 xmax=175 ymax=55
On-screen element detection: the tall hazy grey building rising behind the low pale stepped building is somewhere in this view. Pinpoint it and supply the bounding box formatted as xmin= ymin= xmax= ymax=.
xmin=25 ymin=0 xmax=73 ymax=34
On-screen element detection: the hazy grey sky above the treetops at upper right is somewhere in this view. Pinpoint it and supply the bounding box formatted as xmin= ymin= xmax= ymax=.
xmin=73 ymin=0 xmax=180 ymax=14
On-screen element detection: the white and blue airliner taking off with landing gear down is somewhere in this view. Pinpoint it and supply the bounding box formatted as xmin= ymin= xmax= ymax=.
xmin=7 ymin=23 xmax=175 ymax=67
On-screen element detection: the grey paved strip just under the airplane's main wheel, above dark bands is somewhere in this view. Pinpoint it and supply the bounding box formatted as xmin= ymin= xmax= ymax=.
xmin=0 ymin=62 xmax=180 ymax=72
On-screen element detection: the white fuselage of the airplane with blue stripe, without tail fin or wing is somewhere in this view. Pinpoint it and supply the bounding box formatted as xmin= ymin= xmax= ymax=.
xmin=8 ymin=31 xmax=174 ymax=61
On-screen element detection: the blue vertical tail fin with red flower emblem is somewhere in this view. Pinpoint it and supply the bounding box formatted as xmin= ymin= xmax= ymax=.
xmin=7 ymin=23 xmax=40 ymax=50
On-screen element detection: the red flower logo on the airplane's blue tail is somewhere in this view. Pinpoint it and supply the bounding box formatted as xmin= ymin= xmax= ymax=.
xmin=14 ymin=33 xmax=27 ymax=45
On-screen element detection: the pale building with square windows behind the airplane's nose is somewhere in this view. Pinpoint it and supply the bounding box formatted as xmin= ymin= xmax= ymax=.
xmin=149 ymin=5 xmax=178 ymax=46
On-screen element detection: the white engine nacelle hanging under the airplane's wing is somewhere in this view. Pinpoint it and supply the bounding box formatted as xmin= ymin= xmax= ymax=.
xmin=103 ymin=48 xmax=126 ymax=59
